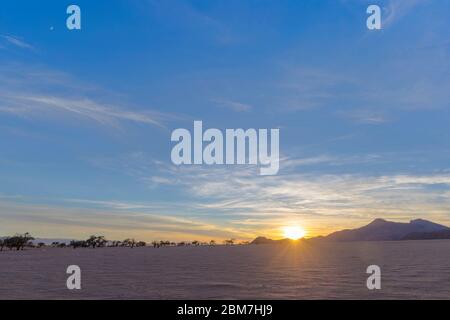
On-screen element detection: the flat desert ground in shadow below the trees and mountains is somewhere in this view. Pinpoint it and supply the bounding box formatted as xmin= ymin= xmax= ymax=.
xmin=0 ymin=240 xmax=450 ymax=299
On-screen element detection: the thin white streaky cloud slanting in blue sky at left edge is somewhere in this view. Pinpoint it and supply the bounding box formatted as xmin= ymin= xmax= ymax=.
xmin=0 ymin=65 xmax=170 ymax=127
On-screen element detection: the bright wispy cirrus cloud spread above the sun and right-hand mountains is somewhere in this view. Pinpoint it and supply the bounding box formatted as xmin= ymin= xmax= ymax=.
xmin=82 ymin=149 xmax=450 ymax=235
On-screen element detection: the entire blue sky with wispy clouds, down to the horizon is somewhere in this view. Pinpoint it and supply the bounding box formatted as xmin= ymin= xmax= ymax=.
xmin=0 ymin=0 xmax=450 ymax=241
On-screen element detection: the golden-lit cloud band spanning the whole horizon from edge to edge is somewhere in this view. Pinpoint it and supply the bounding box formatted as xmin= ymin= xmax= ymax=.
xmin=0 ymin=154 xmax=450 ymax=240
